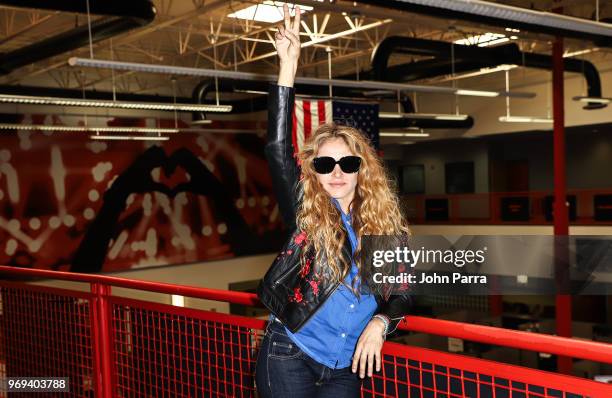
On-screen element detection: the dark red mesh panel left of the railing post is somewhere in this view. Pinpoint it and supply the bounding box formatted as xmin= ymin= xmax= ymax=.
xmin=0 ymin=286 xmax=93 ymax=397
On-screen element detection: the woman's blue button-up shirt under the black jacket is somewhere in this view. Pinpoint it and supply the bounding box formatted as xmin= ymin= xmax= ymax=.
xmin=278 ymin=199 xmax=378 ymax=369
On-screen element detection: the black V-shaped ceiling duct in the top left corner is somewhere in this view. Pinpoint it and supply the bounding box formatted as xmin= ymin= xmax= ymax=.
xmin=0 ymin=0 xmax=156 ymax=74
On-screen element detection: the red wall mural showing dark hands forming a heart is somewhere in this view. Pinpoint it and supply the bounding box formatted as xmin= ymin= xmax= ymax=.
xmin=0 ymin=115 xmax=283 ymax=272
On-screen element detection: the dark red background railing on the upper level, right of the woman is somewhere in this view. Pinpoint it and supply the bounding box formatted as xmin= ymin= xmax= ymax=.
xmin=402 ymin=189 xmax=612 ymax=225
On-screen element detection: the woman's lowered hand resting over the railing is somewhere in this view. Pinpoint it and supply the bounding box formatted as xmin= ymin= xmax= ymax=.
xmin=352 ymin=318 xmax=385 ymax=378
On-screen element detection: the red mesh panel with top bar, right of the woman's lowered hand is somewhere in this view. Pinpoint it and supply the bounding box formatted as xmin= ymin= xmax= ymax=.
xmin=361 ymin=343 xmax=612 ymax=398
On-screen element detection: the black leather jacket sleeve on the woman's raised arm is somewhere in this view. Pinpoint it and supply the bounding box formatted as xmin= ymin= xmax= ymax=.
xmin=264 ymin=84 xmax=300 ymax=230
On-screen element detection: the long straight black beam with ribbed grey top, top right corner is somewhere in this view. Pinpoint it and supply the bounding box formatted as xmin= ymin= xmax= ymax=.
xmin=357 ymin=0 xmax=612 ymax=47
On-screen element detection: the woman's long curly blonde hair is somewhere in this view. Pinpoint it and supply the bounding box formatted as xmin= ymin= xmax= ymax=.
xmin=297 ymin=123 xmax=410 ymax=295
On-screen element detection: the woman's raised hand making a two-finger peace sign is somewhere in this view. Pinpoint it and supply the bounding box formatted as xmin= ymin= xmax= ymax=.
xmin=274 ymin=4 xmax=301 ymax=87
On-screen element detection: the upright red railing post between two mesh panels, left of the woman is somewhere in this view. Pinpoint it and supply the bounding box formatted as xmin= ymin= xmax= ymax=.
xmin=91 ymin=283 xmax=115 ymax=398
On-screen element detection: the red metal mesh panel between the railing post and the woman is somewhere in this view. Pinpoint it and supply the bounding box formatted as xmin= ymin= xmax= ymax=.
xmin=113 ymin=302 xmax=263 ymax=397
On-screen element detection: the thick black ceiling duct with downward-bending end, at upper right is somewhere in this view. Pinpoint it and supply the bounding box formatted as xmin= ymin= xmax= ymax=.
xmin=370 ymin=36 xmax=606 ymax=109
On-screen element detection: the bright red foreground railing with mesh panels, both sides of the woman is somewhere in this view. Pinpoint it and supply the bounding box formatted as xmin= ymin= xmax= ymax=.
xmin=0 ymin=266 xmax=612 ymax=398
